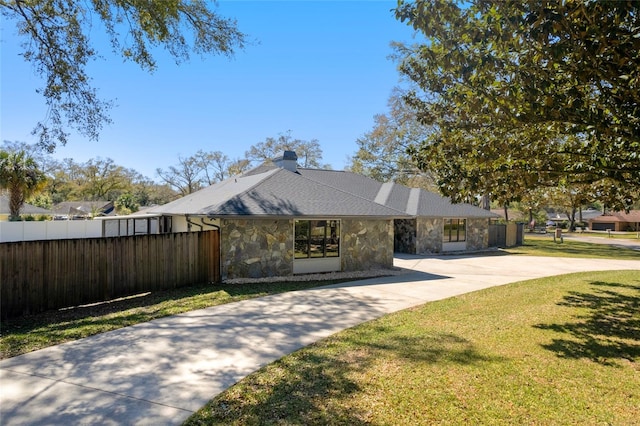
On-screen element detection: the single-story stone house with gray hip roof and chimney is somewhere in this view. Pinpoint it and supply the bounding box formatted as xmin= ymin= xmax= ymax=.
xmin=141 ymin=151 xmax=496 ymax=280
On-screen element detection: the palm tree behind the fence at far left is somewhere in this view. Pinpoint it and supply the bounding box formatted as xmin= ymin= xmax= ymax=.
xmin=0 ymin=150 xmax=47 ymax=220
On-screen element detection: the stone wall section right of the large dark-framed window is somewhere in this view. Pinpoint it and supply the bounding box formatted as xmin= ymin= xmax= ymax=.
xmin=340 ymin=219 xmax=393 ymax=272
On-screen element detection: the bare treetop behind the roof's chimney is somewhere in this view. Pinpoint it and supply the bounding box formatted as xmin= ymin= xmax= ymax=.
xmin=245 ymin=131 xmax=328 ymax=168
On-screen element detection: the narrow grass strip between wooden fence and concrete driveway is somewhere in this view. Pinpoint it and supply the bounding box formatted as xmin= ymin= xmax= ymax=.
xmin=0 ymin=280 xmax=356 ymax=359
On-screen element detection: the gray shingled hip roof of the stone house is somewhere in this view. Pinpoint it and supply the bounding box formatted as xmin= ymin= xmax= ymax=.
xmin=150 ymin=162 xmax=498 ymax=218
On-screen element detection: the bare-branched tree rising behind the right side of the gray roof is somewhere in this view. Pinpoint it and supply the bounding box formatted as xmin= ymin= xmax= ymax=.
xmin=348 ymin=89 xmax=434 ymax=189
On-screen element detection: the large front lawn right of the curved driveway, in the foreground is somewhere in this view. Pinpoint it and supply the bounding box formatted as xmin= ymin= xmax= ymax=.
xmin=186 ymin=271 xmax=640 ymax=425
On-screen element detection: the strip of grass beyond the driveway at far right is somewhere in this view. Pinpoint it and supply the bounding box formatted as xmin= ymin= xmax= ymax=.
xmin=504 ymin=234 xmax=640 ymax=260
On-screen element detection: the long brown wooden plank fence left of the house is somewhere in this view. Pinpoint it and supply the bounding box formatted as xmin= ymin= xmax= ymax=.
xmin=0 ymin=231 xmax=220 ymax=318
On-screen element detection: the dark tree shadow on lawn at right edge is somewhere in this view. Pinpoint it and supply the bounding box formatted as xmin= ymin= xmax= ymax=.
xmin=535 ymin=281 xmax=640 ymax=366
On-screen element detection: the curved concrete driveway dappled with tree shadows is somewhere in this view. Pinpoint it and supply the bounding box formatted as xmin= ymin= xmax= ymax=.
xmin=0 ymin=254 xmax=640 ymax=425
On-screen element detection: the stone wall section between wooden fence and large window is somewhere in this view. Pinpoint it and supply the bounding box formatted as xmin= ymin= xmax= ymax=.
xmin=220 ymin=219 xmax=293 ymax=280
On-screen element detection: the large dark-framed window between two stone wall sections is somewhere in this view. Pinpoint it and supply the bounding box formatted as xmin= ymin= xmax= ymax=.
xmin=295 ymin=220 xmax=340 ymax=259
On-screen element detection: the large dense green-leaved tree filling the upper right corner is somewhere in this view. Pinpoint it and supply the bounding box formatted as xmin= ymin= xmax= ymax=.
xmin=396 ymin=0 xmax=640 ymax=209
